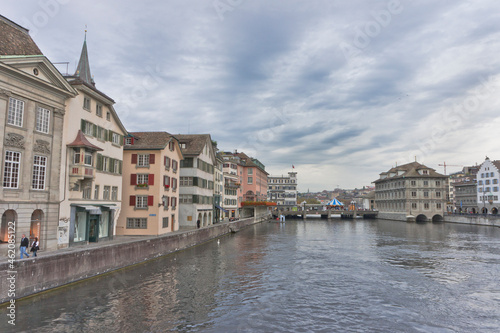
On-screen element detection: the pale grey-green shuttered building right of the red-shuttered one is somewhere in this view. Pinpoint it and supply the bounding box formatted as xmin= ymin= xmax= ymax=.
xmin=175 ymin=134 xmax=216 ymax=228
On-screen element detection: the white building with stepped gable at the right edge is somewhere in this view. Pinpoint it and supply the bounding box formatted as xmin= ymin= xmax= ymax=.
xmin=477 ymin=157 xmax=500 ymax=214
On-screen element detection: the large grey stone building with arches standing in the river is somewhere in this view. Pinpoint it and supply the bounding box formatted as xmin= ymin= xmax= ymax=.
xmin=373 ymin=162 xmax=448 ymax=222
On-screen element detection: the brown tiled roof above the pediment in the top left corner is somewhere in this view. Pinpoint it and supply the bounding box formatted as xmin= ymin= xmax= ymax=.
xmin=0 ymin=15 xmax=43 ymax=56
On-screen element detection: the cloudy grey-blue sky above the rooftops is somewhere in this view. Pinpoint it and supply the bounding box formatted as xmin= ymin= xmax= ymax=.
xmin=2 ymin=0 xmax=500 ymax=191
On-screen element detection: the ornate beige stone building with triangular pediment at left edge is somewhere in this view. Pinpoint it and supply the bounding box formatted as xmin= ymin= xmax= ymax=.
xmin=0 ymin=16 xmax=77 ymax=250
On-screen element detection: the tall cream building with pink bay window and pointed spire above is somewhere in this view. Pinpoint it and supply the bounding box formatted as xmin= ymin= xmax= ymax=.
xmin=58 ymin=40 xmax=126 ymax=248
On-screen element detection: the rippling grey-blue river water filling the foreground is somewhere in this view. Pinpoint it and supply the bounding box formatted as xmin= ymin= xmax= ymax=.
xmin=0 ymin=219 xmax=500 ymax=333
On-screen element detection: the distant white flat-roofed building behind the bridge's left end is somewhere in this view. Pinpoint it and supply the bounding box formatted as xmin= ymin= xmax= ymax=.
xmin=267 ymin=172 xmax=298 ymax=206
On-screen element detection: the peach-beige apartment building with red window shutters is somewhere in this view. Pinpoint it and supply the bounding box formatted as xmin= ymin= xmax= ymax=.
xmin=116 ymin=132 xmax=183 ymax=236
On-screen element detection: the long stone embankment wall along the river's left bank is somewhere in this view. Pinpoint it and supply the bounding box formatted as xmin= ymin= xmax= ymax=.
xmin=0 ymin=214 xmax=267 ymax=304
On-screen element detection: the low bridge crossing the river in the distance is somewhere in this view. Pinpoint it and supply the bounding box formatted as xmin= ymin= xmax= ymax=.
xmin=272 ymin=205 xmax=378 ymax=219
